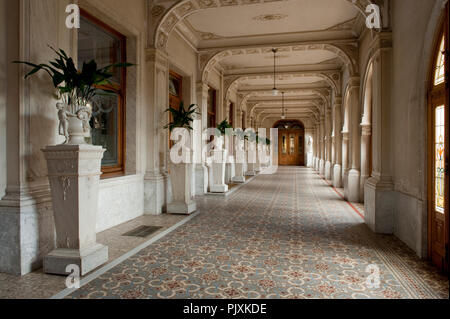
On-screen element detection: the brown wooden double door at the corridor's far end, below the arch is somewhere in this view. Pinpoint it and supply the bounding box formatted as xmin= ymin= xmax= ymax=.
xmin=278 ymin=130 xmax=305 ymax=166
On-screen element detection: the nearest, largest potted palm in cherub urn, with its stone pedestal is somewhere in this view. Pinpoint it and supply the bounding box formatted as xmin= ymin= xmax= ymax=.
xmin=15 ymin=48 xmax=131 ymax=275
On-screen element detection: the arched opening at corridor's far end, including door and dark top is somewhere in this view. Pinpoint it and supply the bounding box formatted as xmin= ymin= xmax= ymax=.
xmin=273 ymin=120 xmax=305 ymax=166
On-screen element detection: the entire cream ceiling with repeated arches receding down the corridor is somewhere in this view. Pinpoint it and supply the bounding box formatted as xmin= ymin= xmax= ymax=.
xmin=162 ymin=0 xmax=370 ymax=127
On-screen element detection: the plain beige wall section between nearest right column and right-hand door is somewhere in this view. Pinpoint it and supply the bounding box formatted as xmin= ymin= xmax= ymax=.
xmin=391 ymin=0 xmax=442 ymax=256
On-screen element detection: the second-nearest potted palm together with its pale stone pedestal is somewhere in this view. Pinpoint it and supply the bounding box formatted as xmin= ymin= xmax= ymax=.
xmin=164 ymin=102 xmax=199 ymax=215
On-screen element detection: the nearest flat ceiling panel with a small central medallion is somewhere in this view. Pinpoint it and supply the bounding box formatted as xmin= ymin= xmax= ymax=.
xmin=185 ymin=0 xmax=360 ymax=48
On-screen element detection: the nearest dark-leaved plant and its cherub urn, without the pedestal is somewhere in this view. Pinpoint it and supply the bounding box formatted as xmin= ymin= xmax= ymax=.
xmin=13 ymin=47 xmax=133 ymax=145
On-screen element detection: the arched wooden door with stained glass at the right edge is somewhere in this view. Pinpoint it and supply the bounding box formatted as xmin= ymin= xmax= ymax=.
xmin=428 ymin=4 xmax=450 ymax=273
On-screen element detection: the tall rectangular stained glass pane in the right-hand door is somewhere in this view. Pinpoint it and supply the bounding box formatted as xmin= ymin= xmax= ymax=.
xmin=435 ymin=105 xmax=445 ymax=214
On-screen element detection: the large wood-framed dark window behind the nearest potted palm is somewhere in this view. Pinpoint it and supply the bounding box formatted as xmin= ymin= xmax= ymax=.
xmin=78 ymin=11 xmax=126 ymax=178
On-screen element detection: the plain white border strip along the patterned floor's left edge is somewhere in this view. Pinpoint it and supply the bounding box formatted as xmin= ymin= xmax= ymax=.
xmin=50 ymin=211 xmax=200 ymax=299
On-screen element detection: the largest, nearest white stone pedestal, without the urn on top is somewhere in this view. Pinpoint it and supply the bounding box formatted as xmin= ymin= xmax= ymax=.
xmin=43 ymin=145 xmax=108 ymax=275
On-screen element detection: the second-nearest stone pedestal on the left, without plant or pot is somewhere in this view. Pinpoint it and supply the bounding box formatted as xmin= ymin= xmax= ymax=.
xmin=167 ymin=163 xmax=197 ymax=215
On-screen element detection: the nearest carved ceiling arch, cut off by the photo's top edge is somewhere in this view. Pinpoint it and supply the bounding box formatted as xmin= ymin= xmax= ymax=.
xmin=149 ymin=0 xmax=384 ymax=51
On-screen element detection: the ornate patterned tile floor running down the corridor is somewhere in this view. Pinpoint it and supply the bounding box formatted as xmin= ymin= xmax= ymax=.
xmin=61 ymin=168 xmax=448 ymax=299
